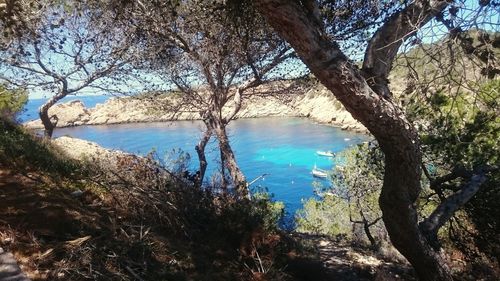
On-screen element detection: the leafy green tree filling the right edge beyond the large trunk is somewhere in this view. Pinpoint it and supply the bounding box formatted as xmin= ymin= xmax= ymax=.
xmin=405 ymin=53 xmax=500 ymax=260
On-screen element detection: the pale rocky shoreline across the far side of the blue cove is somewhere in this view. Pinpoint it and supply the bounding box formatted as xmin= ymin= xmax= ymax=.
xmin=24 ymin=84 xmax=367 ymax=133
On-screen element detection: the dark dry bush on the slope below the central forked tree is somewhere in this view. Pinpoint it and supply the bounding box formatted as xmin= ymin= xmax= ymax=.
xmin=81 ymin=148 xmax=288 ymax=280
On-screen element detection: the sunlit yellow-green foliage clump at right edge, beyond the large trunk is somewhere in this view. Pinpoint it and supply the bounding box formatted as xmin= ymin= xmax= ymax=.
xmin=416 ymin=80 xmax=500 ymax=168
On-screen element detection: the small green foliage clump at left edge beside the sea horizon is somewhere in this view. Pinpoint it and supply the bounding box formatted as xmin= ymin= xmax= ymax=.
xmin=0 ymin=84 xmax=28 ymax=120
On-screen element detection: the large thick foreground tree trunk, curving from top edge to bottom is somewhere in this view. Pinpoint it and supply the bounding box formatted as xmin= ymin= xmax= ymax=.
xmin=257 ymin=0 xmax=452 ymax=281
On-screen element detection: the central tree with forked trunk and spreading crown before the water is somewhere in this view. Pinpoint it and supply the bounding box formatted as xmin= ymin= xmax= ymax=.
xmin=120 ymin=0 xmax=300 ymax=197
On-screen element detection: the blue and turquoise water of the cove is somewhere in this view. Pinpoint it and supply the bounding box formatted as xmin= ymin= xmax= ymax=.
xmin=54 ymin=118 xmax=367 ymax=217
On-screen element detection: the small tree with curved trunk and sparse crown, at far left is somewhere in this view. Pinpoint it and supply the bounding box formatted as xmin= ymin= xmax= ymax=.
xmin=0 ymin=2 xmax=139 ymax=138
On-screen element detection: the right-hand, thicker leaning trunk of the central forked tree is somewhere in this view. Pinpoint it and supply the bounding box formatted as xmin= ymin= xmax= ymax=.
xmin=214 ymin=125 xmax=249 ymax=198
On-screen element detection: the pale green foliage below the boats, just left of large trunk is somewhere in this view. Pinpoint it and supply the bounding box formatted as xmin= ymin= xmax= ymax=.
xmin=296 ymin=143 xmax=383 ymax=243
